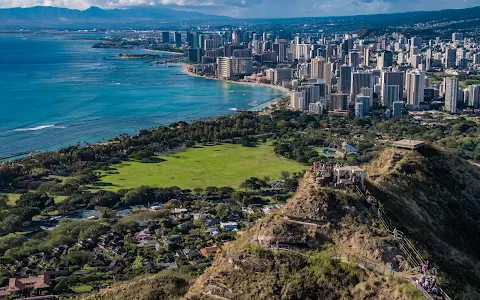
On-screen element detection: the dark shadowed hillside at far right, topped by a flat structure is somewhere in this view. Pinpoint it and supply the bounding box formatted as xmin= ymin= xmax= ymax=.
xmin=367 ymin=146 xmax=480 ymax=299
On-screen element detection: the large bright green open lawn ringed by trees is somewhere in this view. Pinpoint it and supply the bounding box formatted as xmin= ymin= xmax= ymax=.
xmin=94 ymin=144 xmax=306 ymax=190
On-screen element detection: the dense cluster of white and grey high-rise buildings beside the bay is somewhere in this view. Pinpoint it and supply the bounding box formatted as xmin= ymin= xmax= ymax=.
xmin=180 ymin=29 xmax=480 ymax=118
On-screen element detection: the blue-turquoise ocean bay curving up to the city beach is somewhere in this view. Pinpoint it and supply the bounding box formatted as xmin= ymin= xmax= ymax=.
xmin=0 ymin=36 xmax=281 ymax=156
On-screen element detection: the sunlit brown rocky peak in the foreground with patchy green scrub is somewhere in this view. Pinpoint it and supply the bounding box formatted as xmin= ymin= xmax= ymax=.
xmin=186 ymin=175 xmax=421 ymax=299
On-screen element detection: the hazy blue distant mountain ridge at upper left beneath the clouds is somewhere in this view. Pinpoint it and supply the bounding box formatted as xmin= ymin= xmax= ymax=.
xmin=0 ymin=6 xmax=231 ymax=28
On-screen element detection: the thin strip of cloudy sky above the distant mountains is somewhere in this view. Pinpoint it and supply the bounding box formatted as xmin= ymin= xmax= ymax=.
xmin=0 ymin=0 xmax=480 ymax=18
